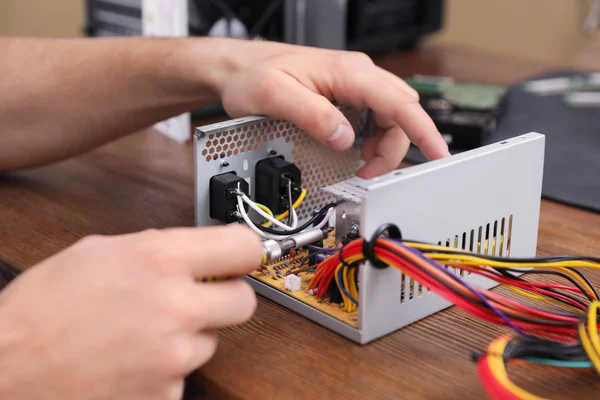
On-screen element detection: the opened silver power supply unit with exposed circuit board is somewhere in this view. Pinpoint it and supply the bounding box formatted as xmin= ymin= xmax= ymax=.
xmin=194 ymin=110 xmax=545 ymax=344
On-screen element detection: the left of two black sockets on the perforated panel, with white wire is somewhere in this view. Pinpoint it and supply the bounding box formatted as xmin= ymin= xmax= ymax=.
xmin=210 ymin=172 xmax=250 ymax=224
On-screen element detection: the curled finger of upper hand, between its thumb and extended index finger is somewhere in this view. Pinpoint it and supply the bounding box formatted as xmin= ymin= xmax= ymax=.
xmin=357 ymin=125 xmax=410 ymax=179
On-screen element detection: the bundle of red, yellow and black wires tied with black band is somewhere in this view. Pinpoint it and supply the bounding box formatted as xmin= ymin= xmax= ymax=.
xmin=309 ymin=225 xmax=600 ymax=399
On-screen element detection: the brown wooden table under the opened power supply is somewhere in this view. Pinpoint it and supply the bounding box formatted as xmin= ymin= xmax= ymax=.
xmin=0 ymin=42 xmax=600 ymax=400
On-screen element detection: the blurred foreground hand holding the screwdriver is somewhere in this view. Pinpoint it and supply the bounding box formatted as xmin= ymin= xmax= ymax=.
xmin=0 ymin=227 xmax=261 ymax=400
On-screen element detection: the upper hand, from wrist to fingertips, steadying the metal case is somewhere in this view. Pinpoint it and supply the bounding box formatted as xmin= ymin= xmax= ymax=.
xmin=209 ymin=40 xmax=449 ymax=178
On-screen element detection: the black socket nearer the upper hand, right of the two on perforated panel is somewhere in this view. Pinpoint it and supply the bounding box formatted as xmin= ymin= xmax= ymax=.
xmin=255 ymin=156 xmax=302 ymax=214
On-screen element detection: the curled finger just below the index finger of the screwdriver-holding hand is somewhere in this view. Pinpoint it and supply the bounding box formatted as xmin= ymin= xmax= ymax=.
xmin=190 ymin=280 xmax=256 ymax=330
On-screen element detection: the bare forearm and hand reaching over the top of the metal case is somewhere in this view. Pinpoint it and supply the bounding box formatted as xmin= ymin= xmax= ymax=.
xmin=0 ymin=38 xmax=449 ymax=178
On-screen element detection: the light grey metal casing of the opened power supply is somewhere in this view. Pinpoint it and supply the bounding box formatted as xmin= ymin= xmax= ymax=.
xmin=195 ymin=111 xmax=545 ymax=343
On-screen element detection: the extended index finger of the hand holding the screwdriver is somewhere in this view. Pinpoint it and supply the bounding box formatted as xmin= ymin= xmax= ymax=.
xmin=141 ymin=224 xmax=262 ymax=279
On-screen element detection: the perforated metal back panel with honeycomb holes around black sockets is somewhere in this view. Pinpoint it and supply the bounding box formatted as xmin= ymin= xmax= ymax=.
xmin=195 ymin=109 xmax=373 ymax=225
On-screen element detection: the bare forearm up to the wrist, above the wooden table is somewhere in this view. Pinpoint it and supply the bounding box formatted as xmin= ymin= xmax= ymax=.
xmin=0 ymin=38 xmax=232 ymax=170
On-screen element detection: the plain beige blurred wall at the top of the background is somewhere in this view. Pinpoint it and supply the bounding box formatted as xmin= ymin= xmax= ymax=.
xmin=0 ymin=0 xmax=600 ymax=65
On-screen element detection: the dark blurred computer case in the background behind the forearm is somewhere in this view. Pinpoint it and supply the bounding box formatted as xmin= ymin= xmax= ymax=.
xmin=86 ymin=0 xmax=444 ymax=53
